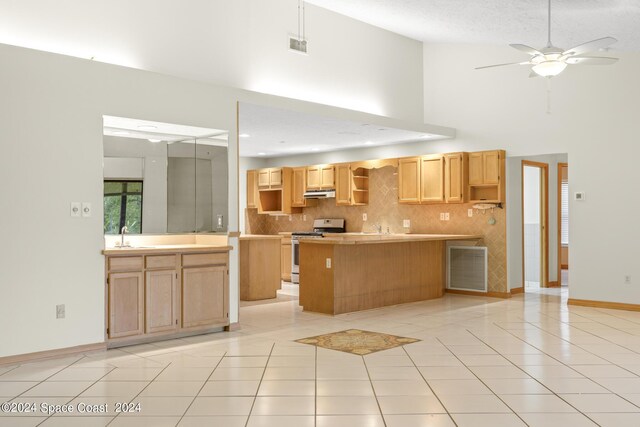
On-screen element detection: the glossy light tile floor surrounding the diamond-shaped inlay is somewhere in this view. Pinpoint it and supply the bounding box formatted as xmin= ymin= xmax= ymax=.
xmin=0 ymin=289 xmax=640 ymax=427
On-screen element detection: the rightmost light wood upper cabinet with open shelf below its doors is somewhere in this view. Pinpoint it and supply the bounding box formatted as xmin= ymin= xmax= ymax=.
xmin=469 ymin=150 xmax=506 ymax=203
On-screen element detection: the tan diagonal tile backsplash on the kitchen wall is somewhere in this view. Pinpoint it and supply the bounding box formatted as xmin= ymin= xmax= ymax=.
xmin=245 ymin=166 xmax=507 ymax=292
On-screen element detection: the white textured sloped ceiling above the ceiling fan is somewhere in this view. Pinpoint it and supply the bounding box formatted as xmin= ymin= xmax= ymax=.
xmin=307 ymin=0 xmax=640 ymax=51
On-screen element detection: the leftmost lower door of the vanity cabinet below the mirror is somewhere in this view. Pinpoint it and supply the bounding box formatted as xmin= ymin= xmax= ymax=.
xmin=108 ymin=272 xmax=144 ymax=338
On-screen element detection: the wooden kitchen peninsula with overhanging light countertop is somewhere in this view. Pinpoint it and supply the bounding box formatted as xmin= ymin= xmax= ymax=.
xmin=300 ymin=233 xmax=482 ymax=314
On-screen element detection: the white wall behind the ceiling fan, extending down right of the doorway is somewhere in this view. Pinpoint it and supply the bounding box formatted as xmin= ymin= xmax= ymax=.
xmin=424 ymin=44 xmax=640 ymax=304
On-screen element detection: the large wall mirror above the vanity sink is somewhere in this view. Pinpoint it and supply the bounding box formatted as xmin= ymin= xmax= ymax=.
xmin=103 ymin=116 xmax=229 ymax=234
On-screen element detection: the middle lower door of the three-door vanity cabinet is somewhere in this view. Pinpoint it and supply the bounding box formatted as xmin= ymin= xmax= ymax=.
xmin=145 ymin=270 xmax=178 ymax=334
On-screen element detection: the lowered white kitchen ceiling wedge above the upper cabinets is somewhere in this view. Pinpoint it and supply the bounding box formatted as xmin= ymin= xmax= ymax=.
xmin=239 ymin=102 xmax=446 ymax=157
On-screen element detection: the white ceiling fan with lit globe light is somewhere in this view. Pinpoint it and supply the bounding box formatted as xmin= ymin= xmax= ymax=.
xmin=476 ymin=0 xmax=618 ymax=77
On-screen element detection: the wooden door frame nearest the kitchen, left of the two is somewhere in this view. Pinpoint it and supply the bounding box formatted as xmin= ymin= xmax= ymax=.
xmin=520 ymin=160 xmax=549 ymax=291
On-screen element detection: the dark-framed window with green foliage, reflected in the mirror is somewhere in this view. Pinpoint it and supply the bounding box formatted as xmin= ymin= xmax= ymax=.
xmin=104 ymin=181 xmax=142 ymax=234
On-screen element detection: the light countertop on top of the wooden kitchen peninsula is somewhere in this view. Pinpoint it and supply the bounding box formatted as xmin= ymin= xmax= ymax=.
xmin=300 ymin=233 xmax=483 ymax=245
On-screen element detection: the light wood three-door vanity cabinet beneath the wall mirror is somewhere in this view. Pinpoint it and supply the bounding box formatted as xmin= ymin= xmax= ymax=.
xmin=105 ymin=247 xmax=229 ymax=347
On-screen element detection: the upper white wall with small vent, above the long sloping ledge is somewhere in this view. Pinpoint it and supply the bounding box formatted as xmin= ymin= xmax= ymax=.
xmin=0 ymin=0 xmax=422 ymax=121
